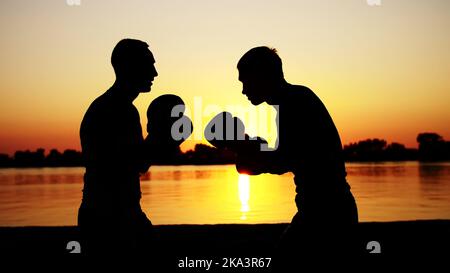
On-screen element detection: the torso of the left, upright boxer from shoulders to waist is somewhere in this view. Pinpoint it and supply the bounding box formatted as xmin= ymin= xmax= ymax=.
xmin=80 ymin=90 xmax=143 ymax=208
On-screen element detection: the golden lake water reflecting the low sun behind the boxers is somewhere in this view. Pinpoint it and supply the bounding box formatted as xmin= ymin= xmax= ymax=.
xmin=0 ymin=162 xmax=450 ymax=226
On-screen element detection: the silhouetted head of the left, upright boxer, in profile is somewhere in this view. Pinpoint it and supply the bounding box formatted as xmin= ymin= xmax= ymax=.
xmin=111 ymin=39 xmax=158 ymax=93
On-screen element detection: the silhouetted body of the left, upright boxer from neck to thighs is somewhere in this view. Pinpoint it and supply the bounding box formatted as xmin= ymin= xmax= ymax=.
xmin=78 ymin=89 xmax=152 ymax=255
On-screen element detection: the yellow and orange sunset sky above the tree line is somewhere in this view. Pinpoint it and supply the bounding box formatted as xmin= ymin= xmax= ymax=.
xmin=0 ymin=0 xmax=450 ymax=154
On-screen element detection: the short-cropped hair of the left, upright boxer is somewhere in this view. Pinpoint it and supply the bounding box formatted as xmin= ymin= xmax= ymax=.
xmin=111 ymin=39 xmax=149 ymax=74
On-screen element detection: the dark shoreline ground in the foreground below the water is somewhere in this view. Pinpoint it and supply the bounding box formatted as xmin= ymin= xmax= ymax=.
xmin=0 ymin=220 xmax=450 ymax=272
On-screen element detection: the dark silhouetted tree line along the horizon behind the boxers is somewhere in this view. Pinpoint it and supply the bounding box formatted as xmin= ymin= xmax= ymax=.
xmin=0 ymin=133 xmax=450 ymax=168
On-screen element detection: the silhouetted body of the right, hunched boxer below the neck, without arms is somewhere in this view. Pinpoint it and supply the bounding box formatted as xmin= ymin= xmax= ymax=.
xmin=270 ymin=85 xmax=358 ymax=258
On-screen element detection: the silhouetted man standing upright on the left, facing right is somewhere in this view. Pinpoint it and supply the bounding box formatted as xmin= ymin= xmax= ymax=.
xmin=78 ymin=39 xmax=158 ymax=254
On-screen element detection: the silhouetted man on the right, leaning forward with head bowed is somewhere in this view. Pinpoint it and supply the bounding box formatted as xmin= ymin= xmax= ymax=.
xmin=236 ymin=47 xmax=358 ymax=254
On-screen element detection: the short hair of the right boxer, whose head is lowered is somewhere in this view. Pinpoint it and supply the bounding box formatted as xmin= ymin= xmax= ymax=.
xmin=237 ymin=46 xmax=284 ymax=78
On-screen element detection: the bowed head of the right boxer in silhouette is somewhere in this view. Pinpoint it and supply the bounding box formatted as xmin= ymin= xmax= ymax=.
xmin=237 ymin=46 xmax=285 ymax=105
